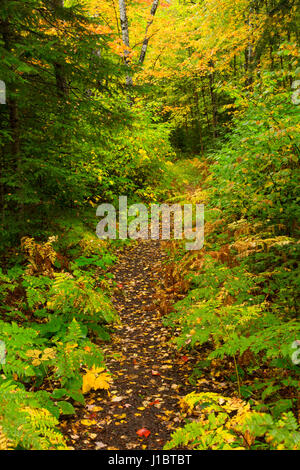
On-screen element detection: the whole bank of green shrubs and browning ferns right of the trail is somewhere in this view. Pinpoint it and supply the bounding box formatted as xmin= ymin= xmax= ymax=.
xmin=158 ymin=73 xmax=300 ymax=449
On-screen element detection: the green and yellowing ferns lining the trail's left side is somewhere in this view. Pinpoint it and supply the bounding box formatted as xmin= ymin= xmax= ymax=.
xmin=0 ymin=230 xmax=117 ymax=449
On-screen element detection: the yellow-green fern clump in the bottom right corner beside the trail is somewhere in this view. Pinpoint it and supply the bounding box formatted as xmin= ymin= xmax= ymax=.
xmin=164 ymin=392 xmax=300 ymax=450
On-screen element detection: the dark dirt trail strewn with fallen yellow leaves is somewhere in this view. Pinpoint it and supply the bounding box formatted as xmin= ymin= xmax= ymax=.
xmin=63 ymin=240 xmax=195 ymax=450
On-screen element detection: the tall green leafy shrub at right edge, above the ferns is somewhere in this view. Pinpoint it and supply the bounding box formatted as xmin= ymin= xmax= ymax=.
xmin=211 ymin=72 xmax=300 ymax=242
